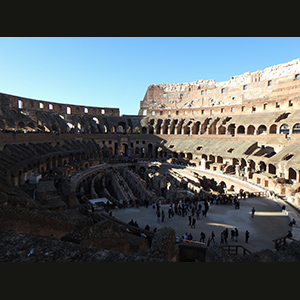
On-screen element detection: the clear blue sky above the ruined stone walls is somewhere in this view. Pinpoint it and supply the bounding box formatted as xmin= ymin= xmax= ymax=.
xmin=0 ymin=37 xmax=300 ymax=115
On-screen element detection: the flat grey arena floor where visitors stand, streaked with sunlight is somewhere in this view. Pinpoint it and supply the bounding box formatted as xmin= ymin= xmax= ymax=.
xmin=113 ymin=197 xmax=292 ymax=252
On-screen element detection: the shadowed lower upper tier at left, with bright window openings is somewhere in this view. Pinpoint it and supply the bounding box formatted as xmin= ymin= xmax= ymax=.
xmin=0 ymin=93 xmax=119 ymax=132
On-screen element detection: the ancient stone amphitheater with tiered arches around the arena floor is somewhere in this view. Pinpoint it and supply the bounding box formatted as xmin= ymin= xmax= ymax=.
xmin=0 ymin=59 xmax=300 ymax=261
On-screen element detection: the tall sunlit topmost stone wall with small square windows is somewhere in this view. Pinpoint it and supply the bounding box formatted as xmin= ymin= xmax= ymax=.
xmin=139 ymin=59 xmax=300 ymax=117
